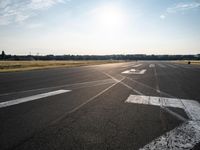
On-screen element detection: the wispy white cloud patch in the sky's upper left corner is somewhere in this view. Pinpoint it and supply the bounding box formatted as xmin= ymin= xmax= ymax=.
xmin=0 ymin=0 xmax=65 ymax=25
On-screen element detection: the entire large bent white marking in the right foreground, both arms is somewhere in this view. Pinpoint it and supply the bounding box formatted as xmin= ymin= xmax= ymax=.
xmin=125 ymin=95 xmax=200 ymax=150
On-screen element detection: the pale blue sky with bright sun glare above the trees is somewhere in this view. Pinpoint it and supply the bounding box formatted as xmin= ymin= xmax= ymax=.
xmin=0 ymin=0 xmax=200 ymax=55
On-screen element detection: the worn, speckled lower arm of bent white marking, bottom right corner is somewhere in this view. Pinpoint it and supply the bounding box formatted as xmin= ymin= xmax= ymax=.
xmin=140 ymin=121 xmax=200 ymax=150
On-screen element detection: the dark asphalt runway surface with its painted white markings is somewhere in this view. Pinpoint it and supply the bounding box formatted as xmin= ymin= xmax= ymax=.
xmin=0 ymin=61 xmax=200 ymax=150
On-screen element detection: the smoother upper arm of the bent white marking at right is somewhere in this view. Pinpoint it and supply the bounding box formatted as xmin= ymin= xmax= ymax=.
xmin=125 ymin=95 xmax=200 ymax=121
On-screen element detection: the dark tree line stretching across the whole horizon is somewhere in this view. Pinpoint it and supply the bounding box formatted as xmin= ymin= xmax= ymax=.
xmin=0 ymin=51 xmax=200 ymax=60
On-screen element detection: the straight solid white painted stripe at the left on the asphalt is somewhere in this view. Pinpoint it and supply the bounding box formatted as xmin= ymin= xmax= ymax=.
xmin=0 ymin=90 xmax=70 ymax=108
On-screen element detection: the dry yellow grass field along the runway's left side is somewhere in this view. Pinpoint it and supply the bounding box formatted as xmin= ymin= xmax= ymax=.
xmin=0 ymin=60 xmax=120 ymax=72
